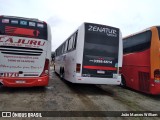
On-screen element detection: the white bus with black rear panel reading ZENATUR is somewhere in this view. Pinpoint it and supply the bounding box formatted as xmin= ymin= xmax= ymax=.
xmin=55 ymin=23 xmax=122 ymax=85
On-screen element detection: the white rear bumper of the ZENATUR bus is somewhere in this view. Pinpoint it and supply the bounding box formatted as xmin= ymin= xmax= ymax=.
xmin=75 ymin=76 xmax=121 ymax=85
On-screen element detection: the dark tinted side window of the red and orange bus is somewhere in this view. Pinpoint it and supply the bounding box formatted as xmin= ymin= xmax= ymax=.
xmin=123 ymin=31 xmax=152 ymax=53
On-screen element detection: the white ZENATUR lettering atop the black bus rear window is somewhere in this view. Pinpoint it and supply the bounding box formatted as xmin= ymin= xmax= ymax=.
xmin=88 ymin=25 xmax=117 ymax=36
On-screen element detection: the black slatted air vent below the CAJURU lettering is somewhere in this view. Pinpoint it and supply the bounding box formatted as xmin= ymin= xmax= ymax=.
xmin=0 ymin=46 xmax=43 ymax=56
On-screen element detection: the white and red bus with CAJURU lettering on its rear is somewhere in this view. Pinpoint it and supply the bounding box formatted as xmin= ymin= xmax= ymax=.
xmin=0 ymin=16 xmax=51 ymax=87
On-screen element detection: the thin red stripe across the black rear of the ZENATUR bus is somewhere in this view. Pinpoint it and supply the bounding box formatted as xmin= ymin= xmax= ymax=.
xmin=83 ymin=66 xmax=117 ymax=70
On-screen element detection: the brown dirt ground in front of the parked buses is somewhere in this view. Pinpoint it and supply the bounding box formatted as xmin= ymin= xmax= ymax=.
xmin=0 ymin=68 xmax=160 ymax=120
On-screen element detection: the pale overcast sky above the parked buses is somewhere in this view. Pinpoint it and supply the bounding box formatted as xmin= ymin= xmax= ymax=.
xmin=0 ymin=0 xmax=160 ymax=51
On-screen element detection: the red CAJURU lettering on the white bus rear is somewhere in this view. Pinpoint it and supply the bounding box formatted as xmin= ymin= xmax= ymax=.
xmin=0 ymin=37 xmax=45 ymax=46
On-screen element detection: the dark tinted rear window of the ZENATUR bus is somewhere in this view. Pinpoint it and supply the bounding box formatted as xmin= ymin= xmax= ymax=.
xmin=84 ymin=24 xmax=119 ymax=57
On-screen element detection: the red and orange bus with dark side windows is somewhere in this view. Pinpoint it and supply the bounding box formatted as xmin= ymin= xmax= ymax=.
xmin=121 ymin=26 xmax=160 ymax=95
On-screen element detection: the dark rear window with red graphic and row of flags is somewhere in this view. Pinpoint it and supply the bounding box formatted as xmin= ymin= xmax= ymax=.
xmin=0 ymin=17 xmax=47 ymax=40
